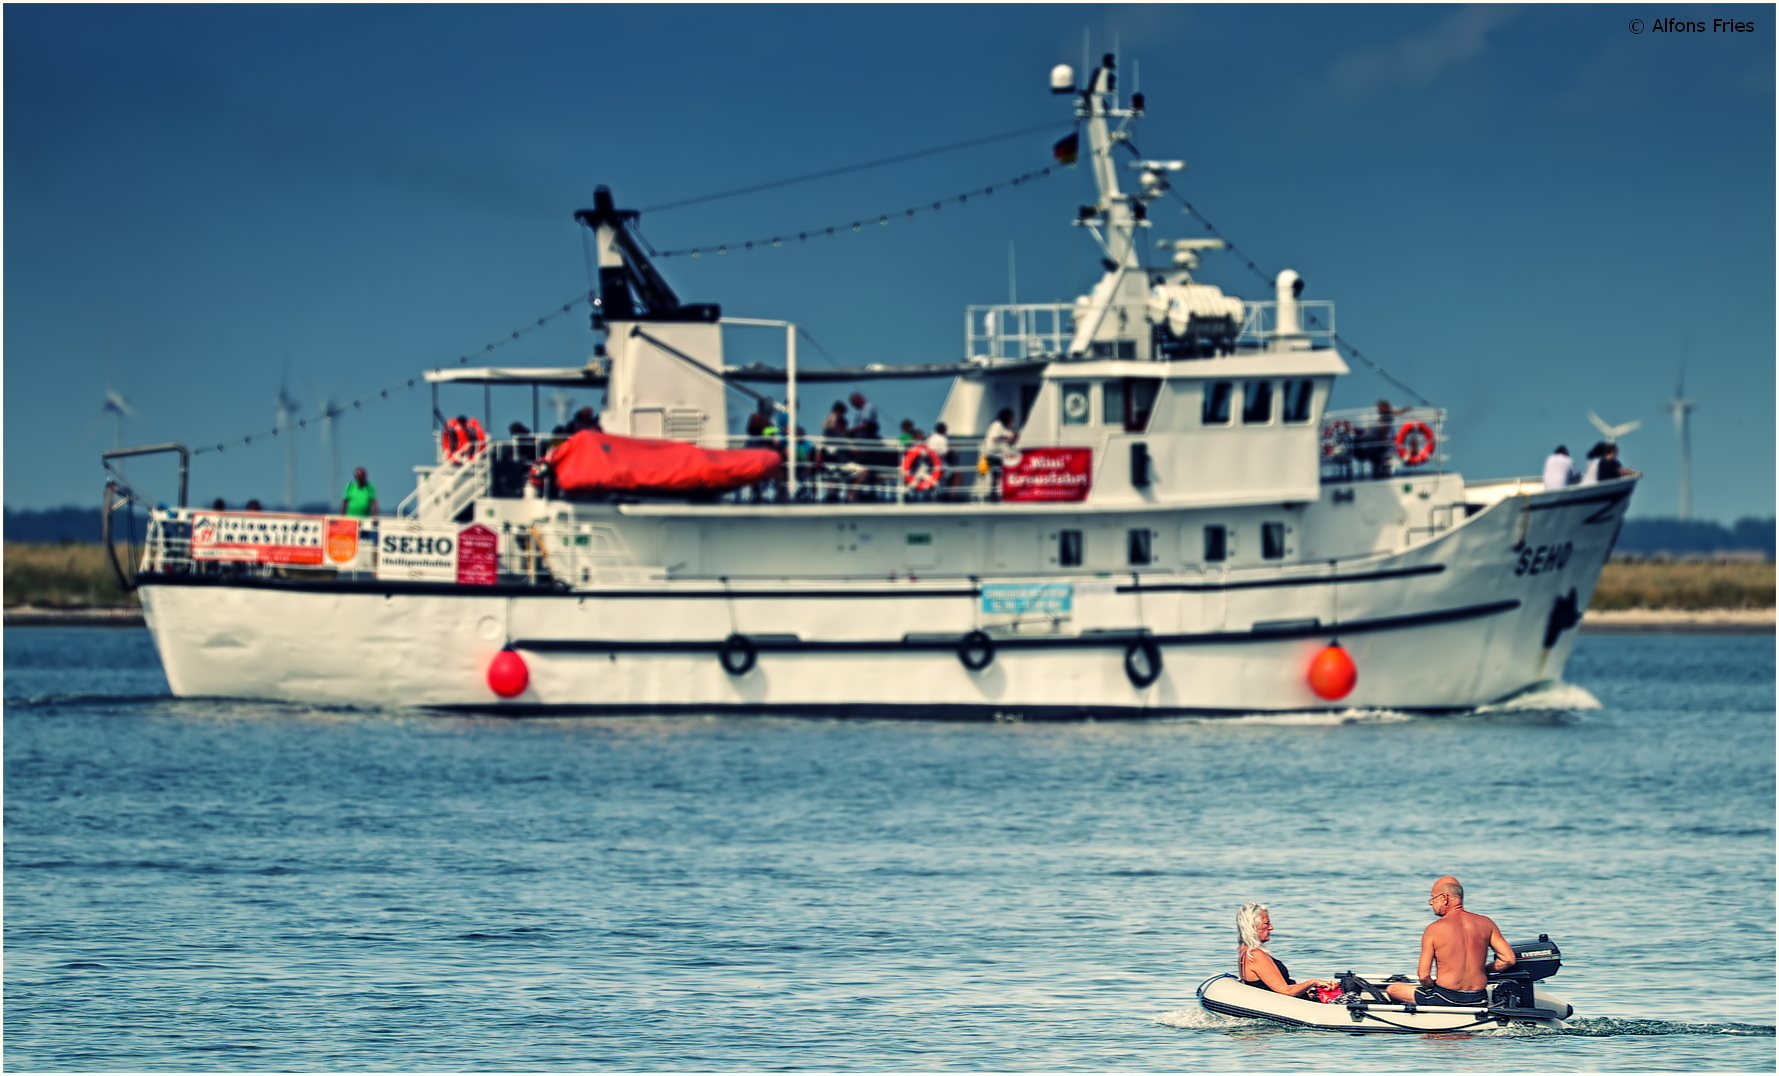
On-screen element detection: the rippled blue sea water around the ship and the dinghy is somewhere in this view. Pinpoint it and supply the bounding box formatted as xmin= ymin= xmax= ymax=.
xmin=5 ymin=628 xmax=1775 ymax=1071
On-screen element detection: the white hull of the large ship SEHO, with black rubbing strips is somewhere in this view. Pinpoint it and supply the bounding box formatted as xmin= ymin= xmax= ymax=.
xmin=142 ymin=486 xmax=1630 ymax=720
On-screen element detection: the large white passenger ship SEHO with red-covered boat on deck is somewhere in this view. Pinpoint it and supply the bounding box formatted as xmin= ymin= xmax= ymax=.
xmin=107 ymin=57 xmax=1635 ymax=719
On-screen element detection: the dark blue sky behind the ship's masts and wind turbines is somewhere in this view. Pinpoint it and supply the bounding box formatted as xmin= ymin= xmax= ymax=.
xmin=4 ymin=5 xmax=1775 ymax=519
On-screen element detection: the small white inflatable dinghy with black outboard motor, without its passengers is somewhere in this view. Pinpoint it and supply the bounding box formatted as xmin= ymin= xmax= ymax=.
xmin=1199 ymin=934 xmax=1574 ymax=1035
